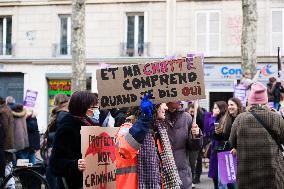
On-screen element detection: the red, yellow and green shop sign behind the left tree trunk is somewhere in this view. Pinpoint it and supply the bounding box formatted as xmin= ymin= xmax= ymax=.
xmin=48 ymin=80 xmax=71 ymax=96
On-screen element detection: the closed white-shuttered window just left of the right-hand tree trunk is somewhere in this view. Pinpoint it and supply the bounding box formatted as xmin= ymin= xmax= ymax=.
xmin=196 ymin=11 xmax=220 ymax=56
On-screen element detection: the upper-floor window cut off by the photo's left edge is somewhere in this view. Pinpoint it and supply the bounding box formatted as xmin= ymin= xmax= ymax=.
xmin=0 ymin=16 xmax=12 ymax=55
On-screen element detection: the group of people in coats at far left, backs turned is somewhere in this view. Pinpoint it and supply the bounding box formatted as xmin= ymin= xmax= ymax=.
xmin=0 ymin=96 xmax=40 ymax=183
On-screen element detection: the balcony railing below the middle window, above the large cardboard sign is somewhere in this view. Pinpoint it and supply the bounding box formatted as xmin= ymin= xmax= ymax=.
xmin=120 ymin=42 xmax=150 ymax=57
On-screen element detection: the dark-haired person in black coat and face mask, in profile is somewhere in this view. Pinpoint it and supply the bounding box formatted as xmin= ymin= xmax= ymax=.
xmin=49 ymin=91 xmax=97 ymax=189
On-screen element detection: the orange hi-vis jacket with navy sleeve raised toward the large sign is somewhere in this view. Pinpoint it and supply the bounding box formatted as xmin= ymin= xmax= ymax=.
xmin=116 ymin=116 xmax=162 ymax=189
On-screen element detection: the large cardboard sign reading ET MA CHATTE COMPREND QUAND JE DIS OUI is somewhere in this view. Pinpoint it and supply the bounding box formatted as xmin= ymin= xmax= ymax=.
xmin=96 ymin=57 xmax=205 ymax=109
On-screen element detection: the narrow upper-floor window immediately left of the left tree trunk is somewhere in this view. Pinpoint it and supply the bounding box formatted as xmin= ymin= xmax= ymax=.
xmin=59 ymin=15 xmax=71 ymax=55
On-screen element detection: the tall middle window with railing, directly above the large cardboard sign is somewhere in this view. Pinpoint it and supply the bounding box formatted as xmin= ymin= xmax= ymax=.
xmin=124 ymin=13 xmax=146 ymax=56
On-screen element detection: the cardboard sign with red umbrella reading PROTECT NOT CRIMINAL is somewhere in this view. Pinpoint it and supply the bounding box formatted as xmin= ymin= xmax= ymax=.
xmin=81 ymin=126 xmax=119 ymax=189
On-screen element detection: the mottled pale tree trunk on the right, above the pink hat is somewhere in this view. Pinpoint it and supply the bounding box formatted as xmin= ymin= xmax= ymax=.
xmin=241 ymin=0 xmax=257 ymax=76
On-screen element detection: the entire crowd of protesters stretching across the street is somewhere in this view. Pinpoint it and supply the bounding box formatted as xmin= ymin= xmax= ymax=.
xmin=0 ymin=75 xmax=284 ymax=189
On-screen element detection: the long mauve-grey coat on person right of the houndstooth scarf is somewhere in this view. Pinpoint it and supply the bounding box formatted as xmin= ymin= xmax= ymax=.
xmin=168 ymin=110 xmax=201 ymax=189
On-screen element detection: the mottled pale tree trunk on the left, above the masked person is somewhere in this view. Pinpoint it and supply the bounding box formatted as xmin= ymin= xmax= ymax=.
xmin=71 ymin=0 xmax=86 ymax=92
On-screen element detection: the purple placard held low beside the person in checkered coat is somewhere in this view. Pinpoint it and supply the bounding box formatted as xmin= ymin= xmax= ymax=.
xmin=218 ymin=151 xmax=237 ymax=184
